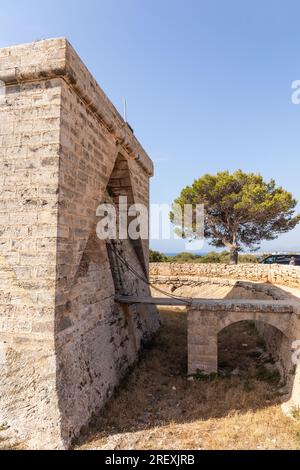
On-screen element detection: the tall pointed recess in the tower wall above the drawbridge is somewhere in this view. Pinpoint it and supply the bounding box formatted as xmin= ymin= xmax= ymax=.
xmin=105 ymin=153 xmax=147 ymax=276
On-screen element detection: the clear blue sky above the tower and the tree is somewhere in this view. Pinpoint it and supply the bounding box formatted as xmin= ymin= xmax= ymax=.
xmin=0 ymin=0 xmax=300 ymax=252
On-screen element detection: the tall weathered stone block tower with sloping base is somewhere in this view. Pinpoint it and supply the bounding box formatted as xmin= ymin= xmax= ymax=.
xmin=0 ymin=39 xmax=159 ymax=448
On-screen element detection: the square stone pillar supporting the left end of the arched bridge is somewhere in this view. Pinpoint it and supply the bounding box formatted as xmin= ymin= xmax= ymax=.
xmin=187 ymin=307 xmax=218 ymax=375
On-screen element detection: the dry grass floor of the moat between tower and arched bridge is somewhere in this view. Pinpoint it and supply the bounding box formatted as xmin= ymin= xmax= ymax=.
xmin=78 ymin=312 xmax=300 ymax=450
